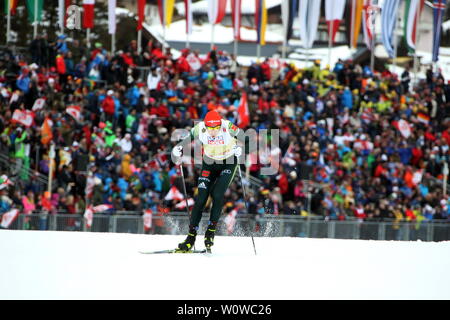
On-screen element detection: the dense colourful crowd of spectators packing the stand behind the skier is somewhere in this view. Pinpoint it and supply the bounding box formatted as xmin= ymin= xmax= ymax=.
xmin=0 ymin=31 xmax=450 ymax=230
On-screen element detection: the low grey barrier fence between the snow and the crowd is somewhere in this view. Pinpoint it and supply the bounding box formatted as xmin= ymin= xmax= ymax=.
xmin=3 ymin=212 xmax=450 ymax=241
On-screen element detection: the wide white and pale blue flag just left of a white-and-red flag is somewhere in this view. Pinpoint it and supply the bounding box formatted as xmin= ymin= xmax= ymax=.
xmin=298 ymin=0 xmax=321 ymax=49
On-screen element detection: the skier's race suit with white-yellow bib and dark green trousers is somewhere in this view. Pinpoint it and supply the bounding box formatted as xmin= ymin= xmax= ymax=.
xmin=181 ymin=120 xmax=250 ymax=228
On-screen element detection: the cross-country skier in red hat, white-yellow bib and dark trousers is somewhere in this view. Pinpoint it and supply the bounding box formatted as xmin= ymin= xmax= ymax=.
xmin=172 ymin=111 xmax=248 ymax=252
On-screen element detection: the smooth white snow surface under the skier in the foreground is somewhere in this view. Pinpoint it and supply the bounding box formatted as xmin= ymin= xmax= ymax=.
xmin=0 ymin=230 xmax=450 ymax=300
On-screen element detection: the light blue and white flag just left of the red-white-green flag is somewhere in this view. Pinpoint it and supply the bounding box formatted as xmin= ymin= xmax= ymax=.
xmin=381 ymin=0 xmax=400 ymax=58
